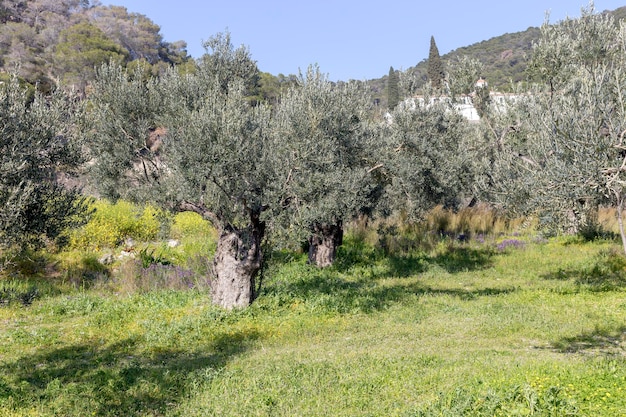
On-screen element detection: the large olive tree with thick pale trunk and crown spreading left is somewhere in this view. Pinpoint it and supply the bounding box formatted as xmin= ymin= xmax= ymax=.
xmin=90 ymin=36 xmax=273 ymax=308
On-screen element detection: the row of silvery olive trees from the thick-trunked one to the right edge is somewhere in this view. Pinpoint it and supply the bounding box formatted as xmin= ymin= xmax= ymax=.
xmin=78 ymin=4 xmax=626 ymax=308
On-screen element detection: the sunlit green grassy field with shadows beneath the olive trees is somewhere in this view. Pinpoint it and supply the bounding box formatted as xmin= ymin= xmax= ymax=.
xmin=0 ymin=214 xmax=626 ymax=416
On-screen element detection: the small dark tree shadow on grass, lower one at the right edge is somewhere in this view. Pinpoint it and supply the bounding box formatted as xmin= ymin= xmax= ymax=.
xmin=552 ymin=326 xmax=626 ymax=357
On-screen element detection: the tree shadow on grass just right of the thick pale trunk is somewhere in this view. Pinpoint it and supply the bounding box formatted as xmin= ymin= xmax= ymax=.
xmin=262 ymin=242 xmax=502 ymax=313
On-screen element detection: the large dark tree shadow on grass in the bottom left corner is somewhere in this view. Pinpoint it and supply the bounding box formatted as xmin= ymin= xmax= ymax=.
xmin=0 ymin=332 xmax=258 ymax=416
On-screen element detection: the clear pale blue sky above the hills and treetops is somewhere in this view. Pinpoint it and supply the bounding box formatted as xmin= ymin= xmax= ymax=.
xmin=101 ymin=0 xmax=626 ymax=80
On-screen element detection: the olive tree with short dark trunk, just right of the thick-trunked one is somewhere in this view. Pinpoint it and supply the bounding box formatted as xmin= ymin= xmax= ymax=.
xmin=273 ymin=67 xmax=376 ymax=267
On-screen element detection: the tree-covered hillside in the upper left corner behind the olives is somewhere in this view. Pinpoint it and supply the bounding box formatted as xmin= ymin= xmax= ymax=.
xmin=0 ymin=0 xmax=189 ymax=91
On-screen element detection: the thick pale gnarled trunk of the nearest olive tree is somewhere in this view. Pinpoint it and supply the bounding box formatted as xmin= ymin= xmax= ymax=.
xmin=211 ymin=218 xmax=264 ymax=310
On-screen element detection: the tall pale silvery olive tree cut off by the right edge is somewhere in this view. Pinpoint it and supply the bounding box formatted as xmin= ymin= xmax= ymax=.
xmin=498 ymin=6 xmax=626 ymax=245
